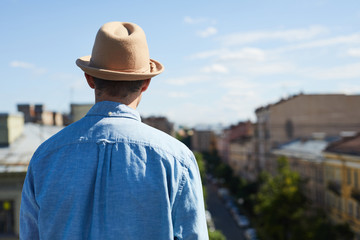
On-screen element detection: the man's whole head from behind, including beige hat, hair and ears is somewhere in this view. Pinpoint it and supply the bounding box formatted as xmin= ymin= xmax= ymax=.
xmin=76 ymin=22 xmax=164 ymax=108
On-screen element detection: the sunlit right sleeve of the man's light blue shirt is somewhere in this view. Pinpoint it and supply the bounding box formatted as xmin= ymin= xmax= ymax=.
xmin=172 ymin=157 xmax=209 ymax=240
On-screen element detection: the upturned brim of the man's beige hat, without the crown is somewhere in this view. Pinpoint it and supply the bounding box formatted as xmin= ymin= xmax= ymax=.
xmin=76 ymin=56 xmax=164 ymax=81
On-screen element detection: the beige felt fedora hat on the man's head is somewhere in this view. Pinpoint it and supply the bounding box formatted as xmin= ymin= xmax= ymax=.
xmin=76 ymin=22 xmax=164 ymax=81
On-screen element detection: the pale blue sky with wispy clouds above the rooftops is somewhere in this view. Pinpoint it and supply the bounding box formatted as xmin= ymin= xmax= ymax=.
xmin=0 ymin=0 xmax=360 ymax=127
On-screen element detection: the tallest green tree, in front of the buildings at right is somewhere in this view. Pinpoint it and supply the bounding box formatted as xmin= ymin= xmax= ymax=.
xmin=255 ymin=158 xmax=307 ymax=240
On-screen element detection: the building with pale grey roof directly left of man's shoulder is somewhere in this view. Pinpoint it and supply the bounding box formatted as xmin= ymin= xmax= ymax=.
xmin=0 ymin=124 xmax=62 ymax=240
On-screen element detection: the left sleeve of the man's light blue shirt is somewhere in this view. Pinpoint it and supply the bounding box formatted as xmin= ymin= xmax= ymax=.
xmin=20 ymin=162 xmax=39 ymax=240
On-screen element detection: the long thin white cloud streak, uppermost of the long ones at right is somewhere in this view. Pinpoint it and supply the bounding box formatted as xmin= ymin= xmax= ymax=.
xmin=220 ymin=26 xmax=328 ymax=45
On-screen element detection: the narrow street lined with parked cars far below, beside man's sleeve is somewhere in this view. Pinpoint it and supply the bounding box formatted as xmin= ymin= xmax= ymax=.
xmin=206 ymin=183 xmax=245 ymax=240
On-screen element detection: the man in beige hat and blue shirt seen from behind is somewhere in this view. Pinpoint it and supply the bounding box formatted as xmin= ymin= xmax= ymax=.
xmin=20 ymin=22 xmax=208 ymax=240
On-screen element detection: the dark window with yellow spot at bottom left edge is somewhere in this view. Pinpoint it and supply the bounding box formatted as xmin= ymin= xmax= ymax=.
xmin=0 ymin=200 xmax=15 ymax=236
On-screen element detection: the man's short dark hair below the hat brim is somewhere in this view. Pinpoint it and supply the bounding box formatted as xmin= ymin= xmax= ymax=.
xmin=93 ymin=77 xmax=145 ymax=98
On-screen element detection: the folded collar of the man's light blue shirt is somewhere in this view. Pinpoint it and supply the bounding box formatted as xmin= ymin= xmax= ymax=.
xmin=86 ymin=101 xmax=141 ymax=121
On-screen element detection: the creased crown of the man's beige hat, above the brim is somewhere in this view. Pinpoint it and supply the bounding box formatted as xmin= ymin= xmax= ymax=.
xmin=89 ymin=22 xmax=150 ymax=73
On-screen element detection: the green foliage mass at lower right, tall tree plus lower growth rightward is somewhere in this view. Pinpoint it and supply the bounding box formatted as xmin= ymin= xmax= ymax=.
xmin=255 ymin=158 xmax=354 ymax=240
